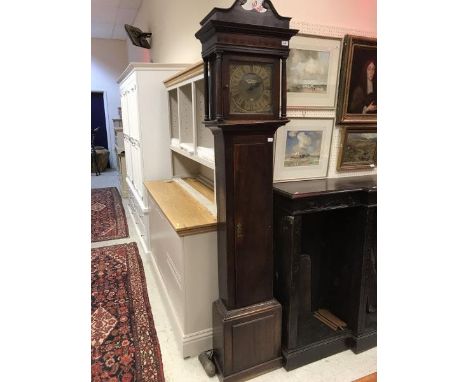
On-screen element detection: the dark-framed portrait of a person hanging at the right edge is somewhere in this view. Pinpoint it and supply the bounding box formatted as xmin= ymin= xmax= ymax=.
xmin=336 ymin=35 xmax=377 ymax=124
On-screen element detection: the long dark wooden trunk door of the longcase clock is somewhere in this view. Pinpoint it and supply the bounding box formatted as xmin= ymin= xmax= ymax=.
xmin=233 ymin=135 xmax=273 ymax=307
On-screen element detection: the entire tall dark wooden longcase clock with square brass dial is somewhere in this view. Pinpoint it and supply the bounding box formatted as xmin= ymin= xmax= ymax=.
xmin=196 ymin=0 xmax=298 ymax=381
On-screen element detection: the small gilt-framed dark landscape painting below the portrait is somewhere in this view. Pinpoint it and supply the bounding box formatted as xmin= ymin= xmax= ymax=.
xmin=337 ymin=126 xmax=377 ymax=171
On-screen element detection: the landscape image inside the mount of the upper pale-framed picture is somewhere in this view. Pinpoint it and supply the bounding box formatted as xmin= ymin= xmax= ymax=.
xmin=287 ymin=49 xmax=330 ymax=93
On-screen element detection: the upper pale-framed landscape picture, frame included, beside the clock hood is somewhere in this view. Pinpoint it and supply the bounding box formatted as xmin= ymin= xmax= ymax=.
xmin=286 ymin=35 xmax=341 ymax=109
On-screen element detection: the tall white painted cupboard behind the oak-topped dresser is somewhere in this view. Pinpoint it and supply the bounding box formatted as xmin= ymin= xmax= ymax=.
xmin=117 ymin=63 xmax=187 ymax=253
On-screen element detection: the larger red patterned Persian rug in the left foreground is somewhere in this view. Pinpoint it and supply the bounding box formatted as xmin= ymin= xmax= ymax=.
xmin=91 ymin=243 xmax=164 ymax=382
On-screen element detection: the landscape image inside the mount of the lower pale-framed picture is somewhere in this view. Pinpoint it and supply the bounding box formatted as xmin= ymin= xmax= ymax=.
xmin=284 ymin=130 xmax=323 ymax=167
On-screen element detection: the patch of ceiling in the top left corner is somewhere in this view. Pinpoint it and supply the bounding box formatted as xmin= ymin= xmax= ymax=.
xmin=91 ymin=0 xmax=142 ymax=40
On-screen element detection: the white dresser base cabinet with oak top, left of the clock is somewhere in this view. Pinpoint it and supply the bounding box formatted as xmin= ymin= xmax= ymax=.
xmin=145 ymin=178 xmax=218 ymax=357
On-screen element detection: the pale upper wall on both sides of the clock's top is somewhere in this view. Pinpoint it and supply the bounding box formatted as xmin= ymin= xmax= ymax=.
xmin=129 ymin=0 xmax=377 ymax=63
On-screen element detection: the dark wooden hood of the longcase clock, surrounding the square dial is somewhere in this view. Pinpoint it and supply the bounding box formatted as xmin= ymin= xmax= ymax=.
xmin=195 ymin=0 xmax=298 ymax=122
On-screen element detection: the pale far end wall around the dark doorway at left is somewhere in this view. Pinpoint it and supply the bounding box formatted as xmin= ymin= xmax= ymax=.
xmin=91 ymin=38 xmax=128 ymax=168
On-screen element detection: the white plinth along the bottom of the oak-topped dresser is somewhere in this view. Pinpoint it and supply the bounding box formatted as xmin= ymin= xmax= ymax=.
xmin=150 ymin=251 xmax=213 ymax=358
